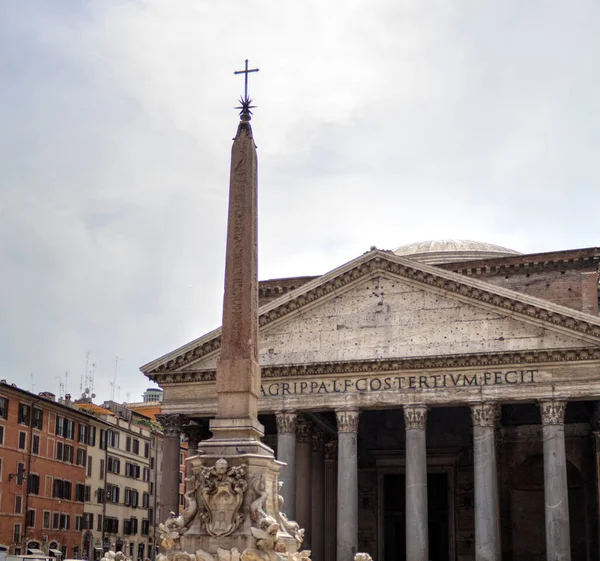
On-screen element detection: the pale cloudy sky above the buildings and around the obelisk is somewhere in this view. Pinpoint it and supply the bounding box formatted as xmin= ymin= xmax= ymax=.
xmin=0 ymin=0 xmax=600 ymax=401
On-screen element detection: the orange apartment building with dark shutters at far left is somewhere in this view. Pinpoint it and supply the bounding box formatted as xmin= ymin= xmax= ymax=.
xmin=0 ymin=382 xmax=98 ymax=558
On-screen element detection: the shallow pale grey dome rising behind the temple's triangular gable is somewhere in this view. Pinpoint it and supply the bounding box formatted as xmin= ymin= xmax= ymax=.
xmin=392 ymin=240 xmax=521 ymax=265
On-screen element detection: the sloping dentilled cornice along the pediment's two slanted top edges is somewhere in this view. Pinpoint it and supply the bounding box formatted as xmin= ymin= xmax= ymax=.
xmin=141 ymin=250 xmax=600 ymax=381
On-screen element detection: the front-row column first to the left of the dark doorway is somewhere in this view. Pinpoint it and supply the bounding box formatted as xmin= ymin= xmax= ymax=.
xmin=336 ymin=409 xmax=359 ymax=561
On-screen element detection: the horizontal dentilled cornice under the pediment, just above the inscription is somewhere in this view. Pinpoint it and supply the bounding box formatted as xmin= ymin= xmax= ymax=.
xmin=152 ymin=348 xmax=600 ymax=385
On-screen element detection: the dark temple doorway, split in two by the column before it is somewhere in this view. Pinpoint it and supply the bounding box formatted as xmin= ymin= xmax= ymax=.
xmin=383 ymin=473 xmax=450 ymax=561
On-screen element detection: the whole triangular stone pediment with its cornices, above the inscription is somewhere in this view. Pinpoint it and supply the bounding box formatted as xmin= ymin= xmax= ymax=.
xmin=142 ymin=251 xmax=600 ymax=377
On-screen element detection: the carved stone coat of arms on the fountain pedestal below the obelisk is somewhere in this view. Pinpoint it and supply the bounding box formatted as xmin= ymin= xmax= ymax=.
xmin=200 ymin=458 xmax=248 ymax=538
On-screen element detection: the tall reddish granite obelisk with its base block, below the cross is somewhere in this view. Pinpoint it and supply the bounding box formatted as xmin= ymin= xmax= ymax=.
xmin=211 ymin=93 xmax=263 ymax=440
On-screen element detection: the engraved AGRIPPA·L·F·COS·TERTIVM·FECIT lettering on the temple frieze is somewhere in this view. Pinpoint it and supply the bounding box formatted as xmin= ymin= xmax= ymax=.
xmin=261 ymin=370 xmax=541 ymax=397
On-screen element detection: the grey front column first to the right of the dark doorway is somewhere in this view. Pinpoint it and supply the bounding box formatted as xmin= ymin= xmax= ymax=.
xmin=471 ymin=403 xmax=502 ymax=561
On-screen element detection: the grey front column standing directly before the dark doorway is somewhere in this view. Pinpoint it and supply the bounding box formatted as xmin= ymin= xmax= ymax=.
xmin=404 ymin=405 xmax=429 ymax=561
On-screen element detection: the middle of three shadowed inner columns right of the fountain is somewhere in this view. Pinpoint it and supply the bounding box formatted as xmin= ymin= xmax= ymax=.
xmin=311 ymin=428 xmax=325 ymax=561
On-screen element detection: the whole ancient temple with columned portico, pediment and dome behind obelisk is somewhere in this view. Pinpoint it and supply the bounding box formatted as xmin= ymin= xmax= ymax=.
xmin=142 ymin=240 xmax=600 ymax=561
